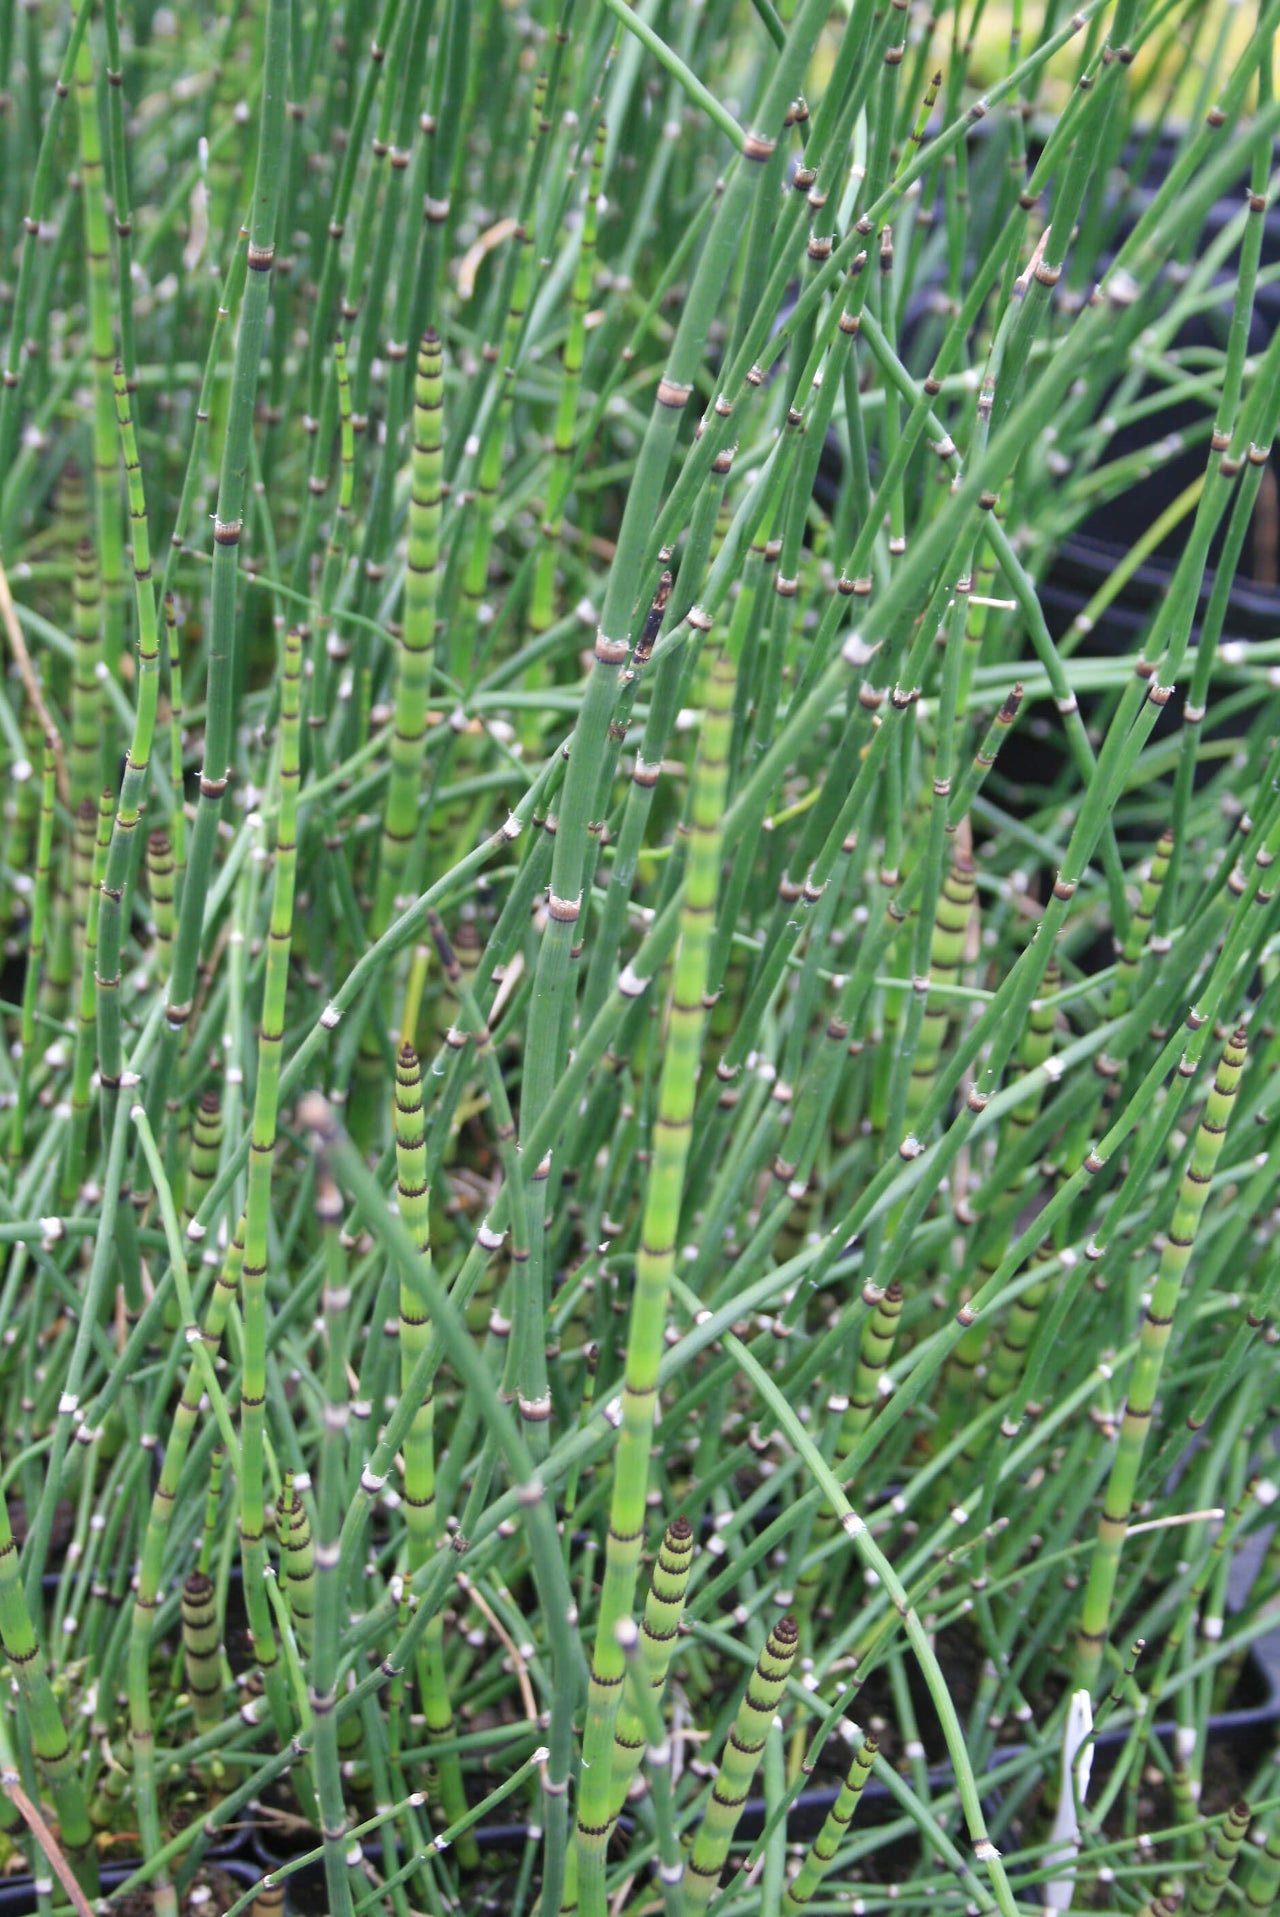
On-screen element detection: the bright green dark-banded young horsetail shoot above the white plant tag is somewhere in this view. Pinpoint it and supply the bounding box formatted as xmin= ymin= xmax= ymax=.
xmin=1075 ymin=1026 xmax=1246 ymax=1691
